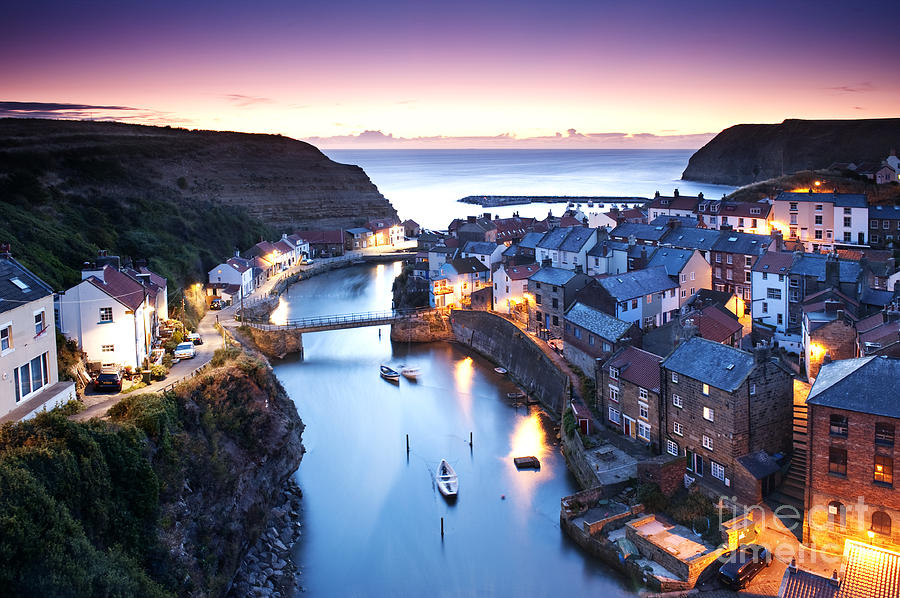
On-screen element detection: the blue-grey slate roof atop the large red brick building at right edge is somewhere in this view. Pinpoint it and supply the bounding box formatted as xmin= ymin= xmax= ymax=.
xmin=806 ymin=356 xmax=900 ymax=418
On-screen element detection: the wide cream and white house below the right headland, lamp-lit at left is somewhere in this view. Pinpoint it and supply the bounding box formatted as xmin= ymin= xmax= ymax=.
xmin=772 ymin=192 xmax=869 ymax=253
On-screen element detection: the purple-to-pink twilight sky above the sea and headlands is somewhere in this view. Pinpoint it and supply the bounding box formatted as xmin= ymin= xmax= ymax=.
xmin=0 ymin=0 xmax=900 ymax=148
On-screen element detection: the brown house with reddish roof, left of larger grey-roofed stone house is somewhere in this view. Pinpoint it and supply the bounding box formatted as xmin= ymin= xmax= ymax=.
xmin=597 ymin=346 xmax=665 ymax=454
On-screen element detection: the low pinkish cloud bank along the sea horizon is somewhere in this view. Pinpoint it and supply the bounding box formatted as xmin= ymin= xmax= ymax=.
xmin=306 ymin=128 xmax=715 ymax=149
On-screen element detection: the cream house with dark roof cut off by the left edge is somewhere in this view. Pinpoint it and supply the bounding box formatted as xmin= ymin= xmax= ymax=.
xmin=0 ymin=251 xmax=75 ymax=423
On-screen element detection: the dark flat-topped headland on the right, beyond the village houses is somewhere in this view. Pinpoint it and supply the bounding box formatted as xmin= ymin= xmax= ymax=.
xmin=681 ymin=118 xmax=900 ymax=186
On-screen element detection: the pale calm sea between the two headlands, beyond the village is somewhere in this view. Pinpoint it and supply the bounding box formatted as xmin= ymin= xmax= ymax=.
xmin=325 ymin=150 xmax=734 ymax=229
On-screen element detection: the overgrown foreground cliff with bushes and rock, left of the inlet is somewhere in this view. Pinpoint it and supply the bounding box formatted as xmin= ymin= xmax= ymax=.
xmin=0 ymin=349 xmax=303 ymax=597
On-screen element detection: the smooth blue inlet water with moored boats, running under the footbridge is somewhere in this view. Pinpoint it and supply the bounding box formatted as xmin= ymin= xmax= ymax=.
xmin=273 ymin=262 xmax=633 ymax=598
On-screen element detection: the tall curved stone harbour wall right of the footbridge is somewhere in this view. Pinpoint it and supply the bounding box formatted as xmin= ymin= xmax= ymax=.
xmin=450 ymin=310 xmax=569 ymax=418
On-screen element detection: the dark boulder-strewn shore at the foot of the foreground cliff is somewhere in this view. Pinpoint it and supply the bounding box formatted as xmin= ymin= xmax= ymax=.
xmin=228 ymin=478 xmax=303 ymax=598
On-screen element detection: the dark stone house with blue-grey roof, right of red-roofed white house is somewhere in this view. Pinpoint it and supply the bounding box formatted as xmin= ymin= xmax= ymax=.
xmin=527 ymin=260 xmax=592 ymax=338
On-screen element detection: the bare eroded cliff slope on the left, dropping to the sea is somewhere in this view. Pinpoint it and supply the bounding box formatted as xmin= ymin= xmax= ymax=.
xmin=0 ymin=119 xmax=396 ymax=231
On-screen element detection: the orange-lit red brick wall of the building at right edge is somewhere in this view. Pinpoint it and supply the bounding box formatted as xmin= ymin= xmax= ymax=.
xmin=804 ymin=405 xmax=900 ymax=550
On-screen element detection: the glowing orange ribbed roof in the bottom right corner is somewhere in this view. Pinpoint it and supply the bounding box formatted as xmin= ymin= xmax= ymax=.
xmin=835 ymin=540 xmax=900 ymax=598
